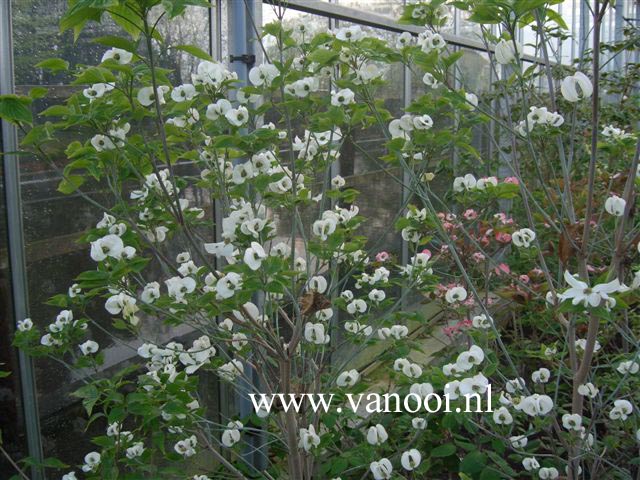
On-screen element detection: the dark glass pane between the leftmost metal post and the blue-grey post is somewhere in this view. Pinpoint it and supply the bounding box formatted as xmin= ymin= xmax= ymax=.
xmin=11 ymin=0 xmax=212 ymax=463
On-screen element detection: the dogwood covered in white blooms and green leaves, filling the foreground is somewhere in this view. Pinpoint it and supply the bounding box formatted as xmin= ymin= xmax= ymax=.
xmin=0 ymin=0 xmax=640 ymax=480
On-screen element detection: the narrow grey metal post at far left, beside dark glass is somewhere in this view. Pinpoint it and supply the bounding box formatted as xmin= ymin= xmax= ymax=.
xmin=0 ymin=1 xmax=44 ymax=480
